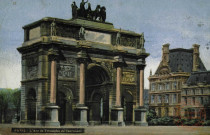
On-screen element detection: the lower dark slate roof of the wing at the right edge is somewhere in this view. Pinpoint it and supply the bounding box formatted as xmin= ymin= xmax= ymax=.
xmin=187 ymin=71 xmax=210 ymax=85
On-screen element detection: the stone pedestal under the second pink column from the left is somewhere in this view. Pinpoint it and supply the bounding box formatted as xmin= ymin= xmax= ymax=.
xmin=74 ymin=106 xmax=88 ymax=126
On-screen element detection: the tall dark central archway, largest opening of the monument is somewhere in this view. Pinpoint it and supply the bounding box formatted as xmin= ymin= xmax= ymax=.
xmin=86 ymin=65 xmax=110 ymax=125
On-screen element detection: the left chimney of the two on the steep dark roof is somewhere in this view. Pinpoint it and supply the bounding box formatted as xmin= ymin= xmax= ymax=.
xmin=162 ymin=43 xmax=170 ymax=66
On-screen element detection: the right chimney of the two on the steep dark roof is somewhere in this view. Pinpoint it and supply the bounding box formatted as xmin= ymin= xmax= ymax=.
xmin=193 ymin=44 xmax=200 ymax=71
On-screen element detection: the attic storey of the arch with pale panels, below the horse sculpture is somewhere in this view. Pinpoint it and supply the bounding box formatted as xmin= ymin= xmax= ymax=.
xmin=23 ymin=17 xmax=144 ymax=49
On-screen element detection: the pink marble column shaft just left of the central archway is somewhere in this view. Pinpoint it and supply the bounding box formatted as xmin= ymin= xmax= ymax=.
xmin=79 ymin=63 xmax=85 ymax=105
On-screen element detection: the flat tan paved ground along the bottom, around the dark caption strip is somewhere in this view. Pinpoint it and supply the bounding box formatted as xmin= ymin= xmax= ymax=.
xmin=0 ymin=124 xmax=210 ymax=135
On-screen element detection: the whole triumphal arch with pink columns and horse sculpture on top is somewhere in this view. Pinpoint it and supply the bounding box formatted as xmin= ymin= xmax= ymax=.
xmin=18 ymin=1 xmax=149 ymax=126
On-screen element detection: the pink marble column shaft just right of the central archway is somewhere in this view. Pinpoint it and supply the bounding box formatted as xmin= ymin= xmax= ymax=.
xmin=116 ymin=67 xmax=122 ymax=106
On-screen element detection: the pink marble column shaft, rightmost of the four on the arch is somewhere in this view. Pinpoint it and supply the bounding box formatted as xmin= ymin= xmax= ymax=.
xmin=139 ymin=69 xmax=144 ymax=106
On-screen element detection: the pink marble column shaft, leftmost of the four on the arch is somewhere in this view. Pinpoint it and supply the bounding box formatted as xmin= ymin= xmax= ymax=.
xmin=50 ymin=60 xmax=57 ymax=104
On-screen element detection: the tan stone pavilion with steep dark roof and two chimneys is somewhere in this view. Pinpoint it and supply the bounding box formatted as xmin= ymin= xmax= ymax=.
xmin=149 ymin=44 xmax=206 ymax=117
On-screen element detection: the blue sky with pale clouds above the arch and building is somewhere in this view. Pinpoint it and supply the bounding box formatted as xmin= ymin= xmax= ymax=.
xmin=0 ymin=0 xmax=210 ymax=88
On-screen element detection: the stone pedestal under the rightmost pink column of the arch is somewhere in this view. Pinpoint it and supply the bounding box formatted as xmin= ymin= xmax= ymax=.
xmin=134 ymin=107 xmax=148 ymax=126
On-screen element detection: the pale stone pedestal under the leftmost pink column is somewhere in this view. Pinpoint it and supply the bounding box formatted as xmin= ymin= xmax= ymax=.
xmin=45 ymin=105 xmax=60 ymax=127
